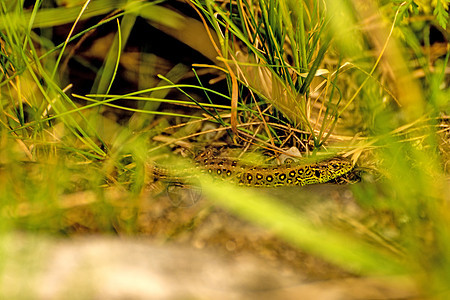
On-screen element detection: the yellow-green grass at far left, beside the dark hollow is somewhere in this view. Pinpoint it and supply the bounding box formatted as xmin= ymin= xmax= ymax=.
xmin=0 ymin=0 xmax=192 ymax=233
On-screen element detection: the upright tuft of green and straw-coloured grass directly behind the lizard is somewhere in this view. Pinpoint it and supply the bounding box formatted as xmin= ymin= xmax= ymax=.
xmin=186 ymin=1 xmax=340 ymax=148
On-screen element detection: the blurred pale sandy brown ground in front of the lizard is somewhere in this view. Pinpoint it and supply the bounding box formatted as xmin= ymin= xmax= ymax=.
xmin=2 ymin=184 xmax=419 ymax=299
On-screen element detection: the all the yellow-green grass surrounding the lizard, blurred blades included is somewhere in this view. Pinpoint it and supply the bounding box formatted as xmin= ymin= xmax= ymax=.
xmin=0 ymin=0 xmax=450 ymax=299
